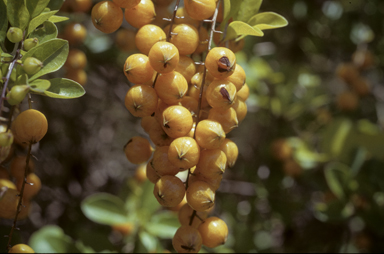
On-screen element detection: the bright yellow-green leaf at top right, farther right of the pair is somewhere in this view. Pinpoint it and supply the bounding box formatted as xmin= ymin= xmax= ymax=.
xmin=248 ymin=12 xmax=288 ymax=30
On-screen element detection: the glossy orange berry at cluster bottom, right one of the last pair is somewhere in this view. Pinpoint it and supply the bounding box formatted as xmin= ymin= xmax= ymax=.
xmin=198 ymin=217 xmax=228 ymax=248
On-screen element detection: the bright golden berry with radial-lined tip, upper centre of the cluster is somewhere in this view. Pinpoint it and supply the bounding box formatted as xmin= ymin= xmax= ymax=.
xmin=148 ymin=41 xmax=181 ymax=75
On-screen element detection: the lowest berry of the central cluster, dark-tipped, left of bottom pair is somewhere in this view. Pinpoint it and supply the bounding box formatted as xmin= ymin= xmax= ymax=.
xmin=172 ymin=226 xmax=202 ymax=253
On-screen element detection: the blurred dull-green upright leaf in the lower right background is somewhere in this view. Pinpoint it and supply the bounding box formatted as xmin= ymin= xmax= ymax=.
xmin=324 ymin=162 xmax=350 ymax=199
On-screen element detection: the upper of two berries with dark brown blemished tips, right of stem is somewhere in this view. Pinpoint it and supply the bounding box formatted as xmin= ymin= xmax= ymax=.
xmin=205 ymin=47 xmax=236 ymax=79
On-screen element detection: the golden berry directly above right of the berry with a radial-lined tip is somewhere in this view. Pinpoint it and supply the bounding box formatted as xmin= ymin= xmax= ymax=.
xmin=164 ymin=24 xmax=199 ymax=55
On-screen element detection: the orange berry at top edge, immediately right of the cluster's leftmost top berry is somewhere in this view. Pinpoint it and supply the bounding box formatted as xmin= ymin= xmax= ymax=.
xmin=125 ymin=0 xmax=156 ymax=28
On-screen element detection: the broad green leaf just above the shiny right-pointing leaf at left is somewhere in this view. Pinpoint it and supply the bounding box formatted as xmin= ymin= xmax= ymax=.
xmin=22 ymin=39 xmax=69 ymax=82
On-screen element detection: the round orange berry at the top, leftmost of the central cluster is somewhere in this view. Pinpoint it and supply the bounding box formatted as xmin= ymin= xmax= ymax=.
xmin=91 ymin=1 xmax=124 ymax=34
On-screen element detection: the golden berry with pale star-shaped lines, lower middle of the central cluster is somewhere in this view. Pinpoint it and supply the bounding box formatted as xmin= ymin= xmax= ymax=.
xmin=168 ymin=137 xmax=200 ymax=169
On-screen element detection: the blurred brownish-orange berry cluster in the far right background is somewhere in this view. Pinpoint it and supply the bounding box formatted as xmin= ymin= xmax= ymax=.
xmin=336 ymin=50 xmax=374 ymax=111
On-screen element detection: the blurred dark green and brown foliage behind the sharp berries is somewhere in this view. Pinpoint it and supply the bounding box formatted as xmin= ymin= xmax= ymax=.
xmin=0 ymin=0 xmax=384 ymax=253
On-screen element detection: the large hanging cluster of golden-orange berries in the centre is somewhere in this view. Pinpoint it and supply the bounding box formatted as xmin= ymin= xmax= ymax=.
xmin=92 ymin=0 xmax=249 ymax=252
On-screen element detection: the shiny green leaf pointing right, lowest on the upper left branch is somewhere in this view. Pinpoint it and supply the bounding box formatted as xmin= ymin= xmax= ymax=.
xmin=43 ymin=78 xmax=85 ymax=99
